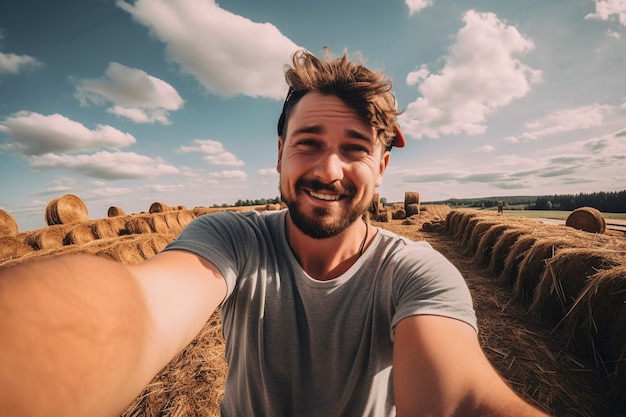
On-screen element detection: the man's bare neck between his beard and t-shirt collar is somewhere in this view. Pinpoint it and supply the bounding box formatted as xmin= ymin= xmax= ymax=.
xmin=285 ymin=214 xmax=376 ymax=281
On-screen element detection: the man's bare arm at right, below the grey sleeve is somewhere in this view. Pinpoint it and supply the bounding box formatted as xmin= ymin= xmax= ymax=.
xmin=393 ymin=315 xmax=547 ymax=417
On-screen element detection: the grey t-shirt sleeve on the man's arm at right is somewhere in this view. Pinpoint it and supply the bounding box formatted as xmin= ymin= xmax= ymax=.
xmin=391 ymin=243 xmax=478 ymax=339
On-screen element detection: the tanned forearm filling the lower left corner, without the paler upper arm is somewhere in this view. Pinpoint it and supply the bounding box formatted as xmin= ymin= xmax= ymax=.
xmin=0 ymin=256 xmax=158 ymax=416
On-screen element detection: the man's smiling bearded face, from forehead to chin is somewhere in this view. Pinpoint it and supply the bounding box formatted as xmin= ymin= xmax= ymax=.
xmin=277 ymin=93 xmax=389 ymax=239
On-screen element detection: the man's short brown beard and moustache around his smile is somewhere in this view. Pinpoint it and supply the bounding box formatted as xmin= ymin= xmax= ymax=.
xmin=280 ymin=179 xmax=369 ymax=239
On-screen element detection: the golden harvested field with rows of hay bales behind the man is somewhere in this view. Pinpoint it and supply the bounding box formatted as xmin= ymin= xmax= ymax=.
xmin=0 ymin=199 xmax=626 ymax=417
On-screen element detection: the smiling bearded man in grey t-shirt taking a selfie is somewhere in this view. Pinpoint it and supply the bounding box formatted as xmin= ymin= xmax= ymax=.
xmin=0 ymin=52 xmax=544 ymax=417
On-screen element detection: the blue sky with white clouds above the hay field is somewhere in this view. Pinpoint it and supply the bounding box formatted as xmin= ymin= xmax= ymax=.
xmin=0 ymin=0 xmax=626 ymax=231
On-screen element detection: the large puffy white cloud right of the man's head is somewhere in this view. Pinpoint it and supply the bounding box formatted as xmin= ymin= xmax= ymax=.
xmin=399 ymin=10 xmax=541 ymax=138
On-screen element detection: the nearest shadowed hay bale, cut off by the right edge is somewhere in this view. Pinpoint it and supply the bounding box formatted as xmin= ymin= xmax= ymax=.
xmin=562 ymin=264 xmax=626 ymax=394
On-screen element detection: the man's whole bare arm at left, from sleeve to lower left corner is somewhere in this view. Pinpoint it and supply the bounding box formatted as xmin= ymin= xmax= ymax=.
xmin=0 ymin=251 xmax=226 ymax=416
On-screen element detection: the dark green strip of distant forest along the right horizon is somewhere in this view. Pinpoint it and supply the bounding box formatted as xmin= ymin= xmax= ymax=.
xmin=423 ymin=190 xmax=626 ymax=213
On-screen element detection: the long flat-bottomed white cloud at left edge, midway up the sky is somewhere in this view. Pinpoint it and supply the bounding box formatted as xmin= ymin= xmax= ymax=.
xmin=0 ymin=111 xmax=136 ymax=155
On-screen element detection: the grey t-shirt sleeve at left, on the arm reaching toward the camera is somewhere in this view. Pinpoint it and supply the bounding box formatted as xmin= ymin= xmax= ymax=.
xmin=164 ymin=212 xmax=254 ymax=298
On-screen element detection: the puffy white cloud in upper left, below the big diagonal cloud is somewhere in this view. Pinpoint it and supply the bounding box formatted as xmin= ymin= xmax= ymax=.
xmin=75 ymin=62 xmax=184 ymax=124
